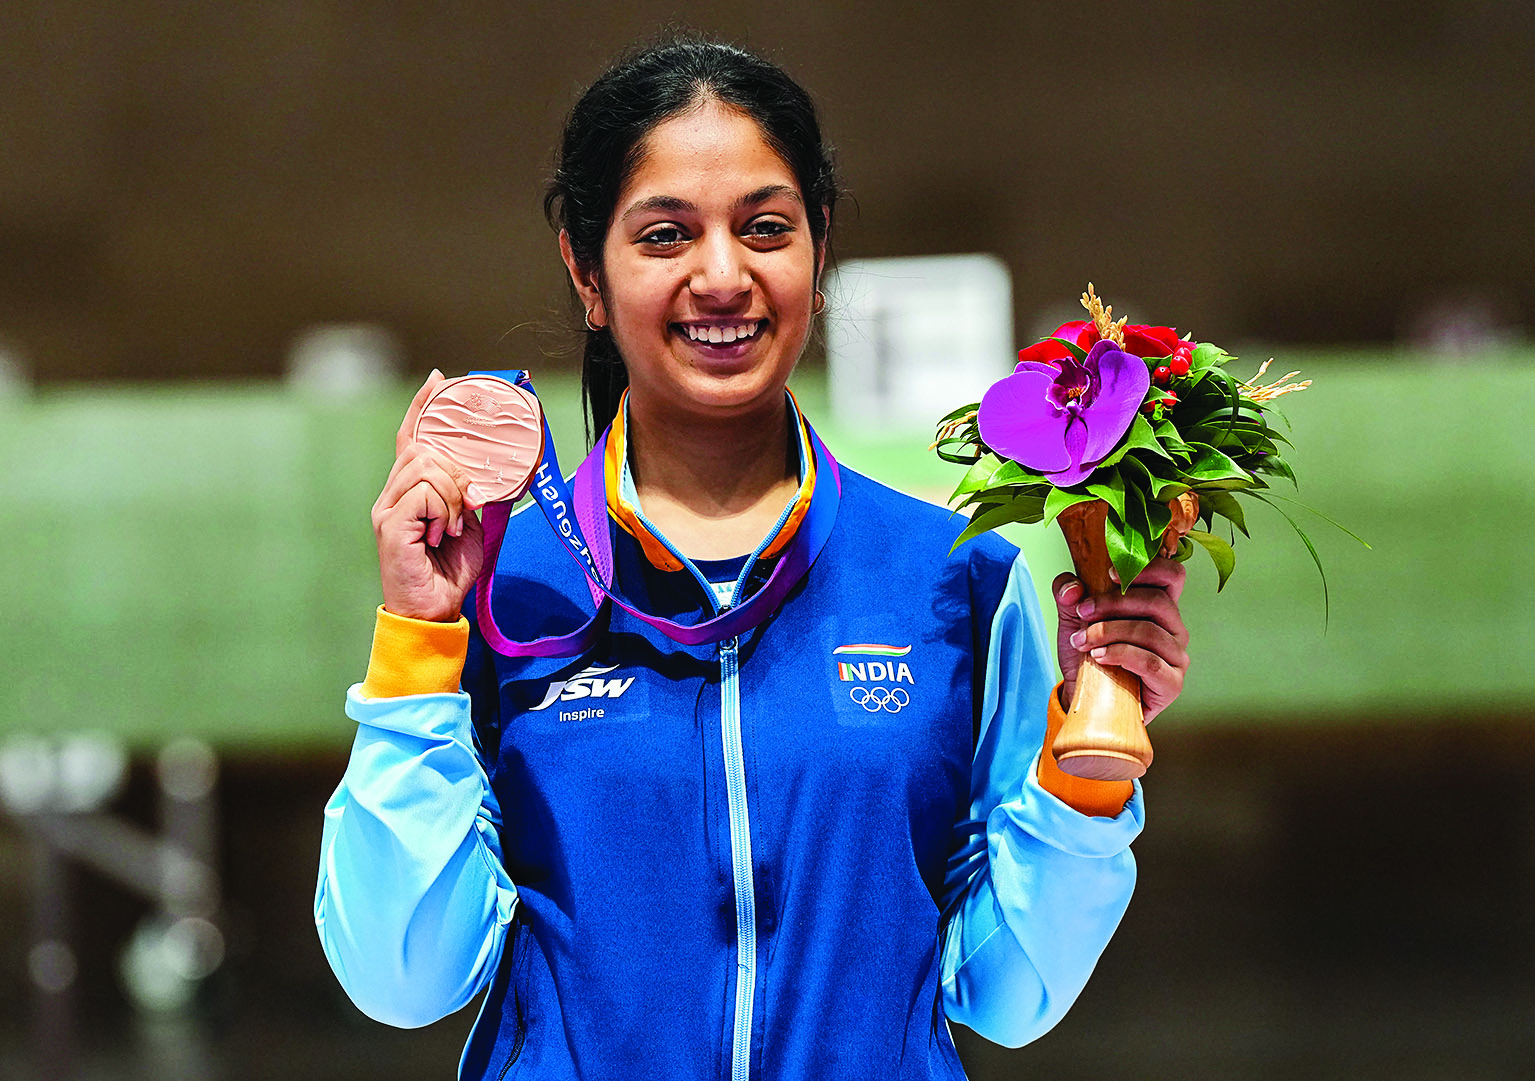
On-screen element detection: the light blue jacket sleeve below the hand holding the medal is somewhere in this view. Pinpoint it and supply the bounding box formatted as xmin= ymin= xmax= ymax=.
xmin=315 ymin=686 xmax=517 ymax=1029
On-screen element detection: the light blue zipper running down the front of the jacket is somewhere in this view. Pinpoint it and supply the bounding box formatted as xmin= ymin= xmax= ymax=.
xmin=720 ymin=639 xmax=757 ymax=1081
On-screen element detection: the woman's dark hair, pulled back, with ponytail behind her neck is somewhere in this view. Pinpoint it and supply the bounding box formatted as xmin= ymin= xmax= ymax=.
xmin=543 ymin=37 xmax=838 ymax=439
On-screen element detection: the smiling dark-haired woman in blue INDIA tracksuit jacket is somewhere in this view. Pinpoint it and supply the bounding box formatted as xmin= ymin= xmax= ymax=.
xmin=315 ymin=33 xmax=1188 ymax=1081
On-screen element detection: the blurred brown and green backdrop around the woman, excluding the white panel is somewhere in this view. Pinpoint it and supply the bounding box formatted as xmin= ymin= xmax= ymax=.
xmin=0 ymin=0 xmax=1535 ymax=1081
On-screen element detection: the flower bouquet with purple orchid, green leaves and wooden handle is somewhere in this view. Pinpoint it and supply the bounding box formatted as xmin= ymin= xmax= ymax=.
xmin=933 ymin=284 xmax=1322 ymax=779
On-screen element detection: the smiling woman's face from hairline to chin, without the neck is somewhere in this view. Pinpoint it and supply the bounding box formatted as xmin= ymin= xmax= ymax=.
xmin=562 ymin=101 xmax=820 ymax=419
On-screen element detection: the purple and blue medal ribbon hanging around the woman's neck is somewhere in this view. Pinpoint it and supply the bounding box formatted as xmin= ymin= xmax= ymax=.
xmin=471 ymin=370 xmax=843 ymax=657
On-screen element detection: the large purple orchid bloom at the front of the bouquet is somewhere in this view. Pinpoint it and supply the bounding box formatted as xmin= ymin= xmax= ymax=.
xmin=976 ymin=341 xmax=1151 ymax=488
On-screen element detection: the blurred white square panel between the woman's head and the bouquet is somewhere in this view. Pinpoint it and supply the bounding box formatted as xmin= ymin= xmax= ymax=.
xmin=826 ymin=255 xmax=1018 ymax=433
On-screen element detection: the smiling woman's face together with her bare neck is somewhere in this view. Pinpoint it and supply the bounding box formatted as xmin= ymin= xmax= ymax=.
xmin=560 ymin=97 xmax=824 ymax=559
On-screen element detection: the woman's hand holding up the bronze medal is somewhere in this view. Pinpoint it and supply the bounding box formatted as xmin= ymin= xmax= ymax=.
xmin=373 ymin=370 xmax=484 ymax=623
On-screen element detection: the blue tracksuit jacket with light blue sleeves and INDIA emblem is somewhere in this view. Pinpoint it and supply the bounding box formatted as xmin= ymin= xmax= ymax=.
xmin=315 ymin=414 xmax=1142 ymax=1081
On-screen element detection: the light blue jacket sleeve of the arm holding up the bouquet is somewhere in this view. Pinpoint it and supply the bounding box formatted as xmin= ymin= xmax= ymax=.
xmin=941 ymin=556 xmax=1144 ymax=1047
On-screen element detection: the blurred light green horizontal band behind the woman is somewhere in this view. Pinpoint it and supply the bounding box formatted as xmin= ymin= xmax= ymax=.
xmin=0 ymin=353 xmax=1535 ymax=749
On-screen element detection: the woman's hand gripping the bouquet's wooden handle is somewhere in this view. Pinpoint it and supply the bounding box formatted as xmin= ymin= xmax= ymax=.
xmin=1050 ymin=556 xmax=1188 ymax=723
